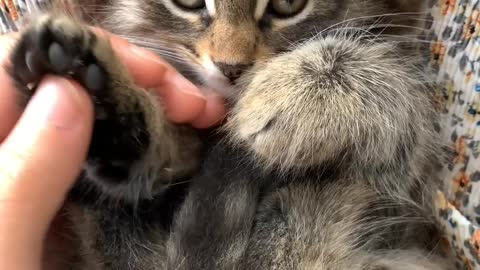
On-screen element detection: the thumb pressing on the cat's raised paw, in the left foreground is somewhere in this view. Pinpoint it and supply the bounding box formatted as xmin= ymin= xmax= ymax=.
xmin=0 ymin=77 xmax=93 ymax=269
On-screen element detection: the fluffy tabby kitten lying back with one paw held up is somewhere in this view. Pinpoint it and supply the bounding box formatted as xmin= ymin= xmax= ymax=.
xmin=5 ymin=0 xmax=452 ymax=270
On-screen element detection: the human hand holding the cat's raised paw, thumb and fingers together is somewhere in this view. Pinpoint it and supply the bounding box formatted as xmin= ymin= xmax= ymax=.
xmin=0 ymin=30 xmax=225 ymax=270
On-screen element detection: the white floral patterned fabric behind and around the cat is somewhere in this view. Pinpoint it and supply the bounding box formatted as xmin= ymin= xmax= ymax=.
xmin=0 ymin=0 xmax=480 ymax=270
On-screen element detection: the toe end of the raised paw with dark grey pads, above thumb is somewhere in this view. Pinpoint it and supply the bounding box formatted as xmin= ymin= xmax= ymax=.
xmin=10 ymin=16 xmax=109 ymax=101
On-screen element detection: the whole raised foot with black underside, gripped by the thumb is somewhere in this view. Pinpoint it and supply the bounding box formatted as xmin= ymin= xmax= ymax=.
xmin=10 ymin=15 xmax=201 ymax=201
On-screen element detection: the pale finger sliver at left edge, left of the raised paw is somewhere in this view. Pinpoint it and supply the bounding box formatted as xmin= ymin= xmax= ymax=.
xmin=0 ymin=35 xmax=20 ymax=142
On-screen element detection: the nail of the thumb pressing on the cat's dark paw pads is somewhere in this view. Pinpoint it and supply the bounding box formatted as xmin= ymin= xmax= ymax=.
xmin=27 ymin=77 xmax=82 ymax=129
